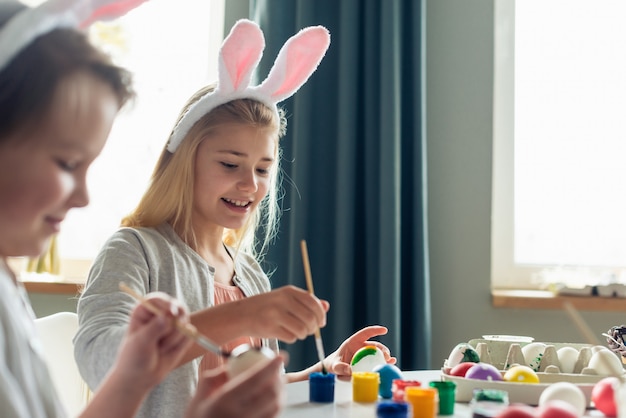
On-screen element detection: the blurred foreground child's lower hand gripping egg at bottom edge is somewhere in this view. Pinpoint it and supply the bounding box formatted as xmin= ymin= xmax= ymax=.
xmin=185 ymin=355 xmax=286 ymax=418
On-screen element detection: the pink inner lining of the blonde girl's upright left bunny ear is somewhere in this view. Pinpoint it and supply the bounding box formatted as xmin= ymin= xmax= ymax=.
xmin=221 ymin=24 xmax=265 ymax=90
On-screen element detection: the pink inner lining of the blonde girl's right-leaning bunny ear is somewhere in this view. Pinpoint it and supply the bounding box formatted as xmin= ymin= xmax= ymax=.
xmin=272 ymin=32 xmax=326 ymax=97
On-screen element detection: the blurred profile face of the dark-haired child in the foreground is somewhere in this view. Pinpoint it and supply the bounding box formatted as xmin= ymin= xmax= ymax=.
xmin=0 ymin=72 xmax=119 ymax=256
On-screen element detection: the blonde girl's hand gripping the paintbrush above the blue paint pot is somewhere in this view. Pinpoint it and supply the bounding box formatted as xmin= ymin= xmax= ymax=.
xmin=238 ymin=286 xmax=330 ymax=343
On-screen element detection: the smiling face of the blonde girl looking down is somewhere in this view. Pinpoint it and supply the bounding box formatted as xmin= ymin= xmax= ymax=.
xmin=193 ymin=123 xmax=277 ymax=233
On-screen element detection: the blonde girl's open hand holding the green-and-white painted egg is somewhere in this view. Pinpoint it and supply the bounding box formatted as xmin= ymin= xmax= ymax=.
xmin=324 ymin=325 xmax=397 ymax=380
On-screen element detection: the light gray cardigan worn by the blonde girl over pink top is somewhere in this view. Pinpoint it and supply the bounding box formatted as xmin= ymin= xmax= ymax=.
xmin=74 ymin=224 xmax=278 ymax=418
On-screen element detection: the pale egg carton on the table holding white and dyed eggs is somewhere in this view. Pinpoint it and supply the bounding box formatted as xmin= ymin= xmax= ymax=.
xmin=442 ymin=336 xmax=624 ymax=405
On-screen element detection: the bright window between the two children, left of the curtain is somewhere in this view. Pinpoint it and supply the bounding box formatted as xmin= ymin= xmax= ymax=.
xmin=16 ymin=0 xmax=224 ymax=279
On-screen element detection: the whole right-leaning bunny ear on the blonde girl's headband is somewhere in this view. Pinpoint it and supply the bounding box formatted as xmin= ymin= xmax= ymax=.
xmin=258 ymin=26 xmax=330 ymax=103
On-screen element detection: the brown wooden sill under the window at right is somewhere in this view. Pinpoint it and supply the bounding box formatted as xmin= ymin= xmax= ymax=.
xmin=491 ymin=289 xmax=626 ymax=312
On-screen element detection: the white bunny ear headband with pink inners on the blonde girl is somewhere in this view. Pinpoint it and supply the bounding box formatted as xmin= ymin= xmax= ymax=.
xmin=167 ymin=19 xmax=330 ymax=153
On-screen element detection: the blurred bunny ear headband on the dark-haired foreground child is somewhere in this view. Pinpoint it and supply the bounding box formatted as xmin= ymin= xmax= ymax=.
xmin=0 ymin=0 xmax=146 ymax=71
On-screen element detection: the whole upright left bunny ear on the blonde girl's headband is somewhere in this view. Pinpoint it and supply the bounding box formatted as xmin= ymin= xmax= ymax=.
xmin=217 ymin=20 xmax=265 ymax=94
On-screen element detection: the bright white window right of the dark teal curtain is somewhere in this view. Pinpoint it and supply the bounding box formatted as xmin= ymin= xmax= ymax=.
xmin=492 ymin=0 xmax=626 ymax=289
